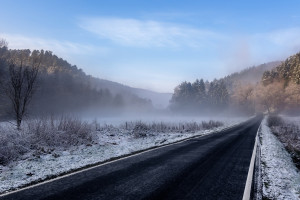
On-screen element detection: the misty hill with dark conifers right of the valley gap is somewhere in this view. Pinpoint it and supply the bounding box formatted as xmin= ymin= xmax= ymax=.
xmin=170 ymin=62 xmax=281 ymax=114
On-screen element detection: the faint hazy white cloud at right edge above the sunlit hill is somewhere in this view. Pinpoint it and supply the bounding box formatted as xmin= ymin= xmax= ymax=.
xmin=220 ymin=27 xmax=300 ymax=73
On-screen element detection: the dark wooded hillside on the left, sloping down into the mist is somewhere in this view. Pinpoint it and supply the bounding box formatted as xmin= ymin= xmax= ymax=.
xmin=0 ymin=40 xmax=152 ymax=121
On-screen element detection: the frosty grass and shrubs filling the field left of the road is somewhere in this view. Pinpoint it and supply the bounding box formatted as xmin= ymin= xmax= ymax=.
xmin=0 ymin=118 xmax=246 ymax=193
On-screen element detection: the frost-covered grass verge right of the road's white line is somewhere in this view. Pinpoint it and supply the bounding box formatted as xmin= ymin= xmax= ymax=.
xmin=260 ymin=118 xmax=300 ymax=199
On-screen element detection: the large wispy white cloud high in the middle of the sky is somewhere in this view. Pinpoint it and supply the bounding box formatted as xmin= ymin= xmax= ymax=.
xmin=79 ymin=17 xmax=220 ymax=47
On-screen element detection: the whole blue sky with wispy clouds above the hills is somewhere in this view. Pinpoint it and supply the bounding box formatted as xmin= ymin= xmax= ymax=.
xmin=0 ymin=0 xmax=300 ymax=92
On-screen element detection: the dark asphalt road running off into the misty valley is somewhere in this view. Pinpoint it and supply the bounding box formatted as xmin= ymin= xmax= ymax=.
xmin=0 ymin=117 xmax=261 ymax=200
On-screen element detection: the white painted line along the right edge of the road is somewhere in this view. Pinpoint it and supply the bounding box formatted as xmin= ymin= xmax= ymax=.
xmin=243 ymin=123 xmax=261 ymax=200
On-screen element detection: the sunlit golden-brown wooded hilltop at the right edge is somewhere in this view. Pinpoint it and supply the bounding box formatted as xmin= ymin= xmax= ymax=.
xmin=262 ymin=53 xmax=300 ymax=86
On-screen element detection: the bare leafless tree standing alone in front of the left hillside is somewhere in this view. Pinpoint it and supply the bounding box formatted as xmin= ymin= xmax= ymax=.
xmin=4 ymin=54 xmax=41 ymax=129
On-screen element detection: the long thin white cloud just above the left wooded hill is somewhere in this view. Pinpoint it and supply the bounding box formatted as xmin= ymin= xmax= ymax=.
xmin=0 ymin=33 xmax=108 ymax=56
